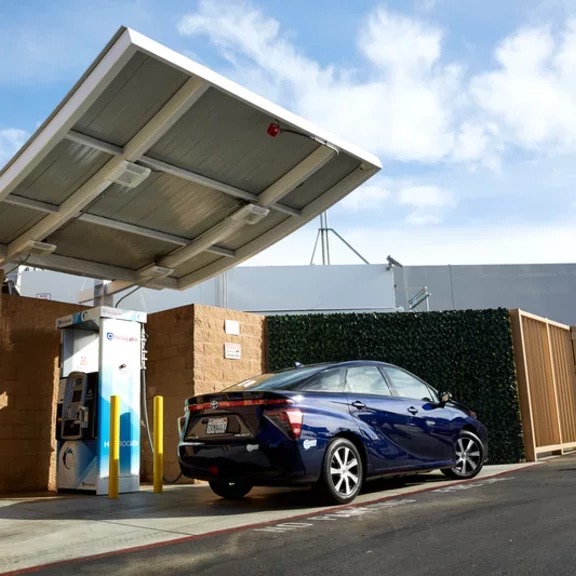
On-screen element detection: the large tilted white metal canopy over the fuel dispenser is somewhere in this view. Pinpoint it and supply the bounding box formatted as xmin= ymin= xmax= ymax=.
xmin=0 ymin=28 xmax=381 ymax=293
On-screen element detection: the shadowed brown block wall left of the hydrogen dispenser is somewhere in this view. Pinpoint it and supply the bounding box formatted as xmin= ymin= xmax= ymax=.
xmin=0 ymin=295 xmax=83 ymax=493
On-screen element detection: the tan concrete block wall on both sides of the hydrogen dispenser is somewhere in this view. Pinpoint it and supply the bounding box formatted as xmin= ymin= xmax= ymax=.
xmin=0 ymin=295 xmax=266 ymax=494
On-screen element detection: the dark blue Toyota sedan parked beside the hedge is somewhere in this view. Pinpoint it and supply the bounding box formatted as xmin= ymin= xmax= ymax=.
xmin=178 ymin=361 xmax=488 ymax=504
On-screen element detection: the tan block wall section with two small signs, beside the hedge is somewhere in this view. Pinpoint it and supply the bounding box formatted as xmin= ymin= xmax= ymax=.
xmin=142 ymin=305 xmax=267 ymax=480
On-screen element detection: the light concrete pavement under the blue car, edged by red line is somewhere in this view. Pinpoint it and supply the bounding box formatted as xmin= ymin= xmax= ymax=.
xmin=0 ymin=464 xmax=533 ymax=573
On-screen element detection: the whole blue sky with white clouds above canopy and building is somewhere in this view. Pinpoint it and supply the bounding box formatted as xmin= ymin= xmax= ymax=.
xmin=0 ymin=0 xmax=576 ymax=264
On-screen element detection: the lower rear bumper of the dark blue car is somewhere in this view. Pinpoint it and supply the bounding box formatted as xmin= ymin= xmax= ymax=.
xmin=178 ymin=442 xmax=319 ymax=486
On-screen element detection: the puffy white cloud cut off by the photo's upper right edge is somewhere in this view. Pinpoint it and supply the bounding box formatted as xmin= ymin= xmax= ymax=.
xmin=470 ymin=18 xmax=576 ymax=153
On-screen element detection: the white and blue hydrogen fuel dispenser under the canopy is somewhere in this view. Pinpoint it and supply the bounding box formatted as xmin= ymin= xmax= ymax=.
xmin=56 ymin=306 xmax=146 ymax=494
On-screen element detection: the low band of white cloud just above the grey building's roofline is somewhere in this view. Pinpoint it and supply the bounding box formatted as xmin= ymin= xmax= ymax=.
xmin=248 ymin=219 xmax=576 ymax=266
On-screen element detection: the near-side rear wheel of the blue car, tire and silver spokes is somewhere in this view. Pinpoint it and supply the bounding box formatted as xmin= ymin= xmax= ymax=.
xmin=316 ymin=438 xmax=364 ymax=504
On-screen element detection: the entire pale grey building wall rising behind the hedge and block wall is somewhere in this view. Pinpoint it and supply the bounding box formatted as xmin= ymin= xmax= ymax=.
xmin=13 ymin=264 xmax=576 ymax=325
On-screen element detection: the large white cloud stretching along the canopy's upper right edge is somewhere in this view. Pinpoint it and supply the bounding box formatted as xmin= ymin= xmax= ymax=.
xmin=179 ymin=0 xmax=488 ymax=162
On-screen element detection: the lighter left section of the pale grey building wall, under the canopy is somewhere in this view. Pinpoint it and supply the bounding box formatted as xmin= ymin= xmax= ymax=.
xmin=15 ymin=265 xmax=396 ymax=314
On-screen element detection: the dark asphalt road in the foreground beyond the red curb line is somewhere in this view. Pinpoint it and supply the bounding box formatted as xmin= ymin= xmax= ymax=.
xmin=13 ymin=456 xmax=576 ymax=576
